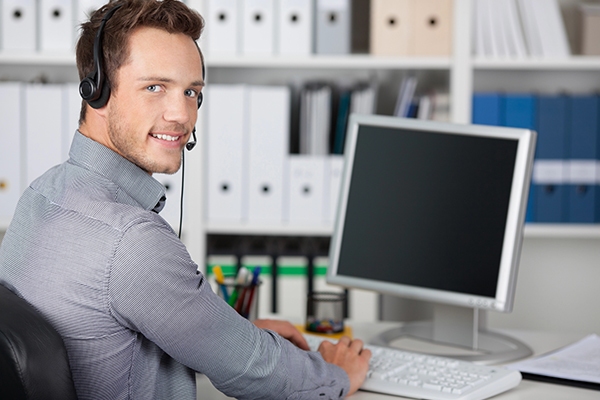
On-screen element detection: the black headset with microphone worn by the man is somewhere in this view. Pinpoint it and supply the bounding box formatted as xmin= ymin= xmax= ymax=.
xmin=79 ymin=4 xmax=206 ymax=151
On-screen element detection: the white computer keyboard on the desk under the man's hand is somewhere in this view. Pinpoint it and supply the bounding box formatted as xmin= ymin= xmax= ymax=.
xmin=304 ymin=335 xmax=521 ymax=400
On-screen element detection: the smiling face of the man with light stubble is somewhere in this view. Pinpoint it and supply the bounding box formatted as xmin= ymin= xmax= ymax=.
xmin=106 ymin=27 xmax=203 ymax=174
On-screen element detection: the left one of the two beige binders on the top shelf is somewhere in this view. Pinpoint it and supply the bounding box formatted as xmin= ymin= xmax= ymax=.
xmin=371 ymin=0 xmax=413 ymax=56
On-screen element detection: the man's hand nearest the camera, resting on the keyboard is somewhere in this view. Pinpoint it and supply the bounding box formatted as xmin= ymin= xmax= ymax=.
xmin=319 ymin=336 xmax=371 ymax=395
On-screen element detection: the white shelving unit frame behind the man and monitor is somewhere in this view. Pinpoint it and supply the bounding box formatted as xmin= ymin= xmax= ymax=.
xmin=0 ymin=0 xmax=600 ymax=260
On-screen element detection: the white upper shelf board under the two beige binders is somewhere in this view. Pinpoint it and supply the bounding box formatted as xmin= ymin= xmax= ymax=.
xmin=206 ymin=54 xmax=452 ymax=70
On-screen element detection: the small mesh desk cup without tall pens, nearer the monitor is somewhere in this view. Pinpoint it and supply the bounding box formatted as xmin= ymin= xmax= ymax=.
xmin=306 ymin=292 xmax=346 ymax=333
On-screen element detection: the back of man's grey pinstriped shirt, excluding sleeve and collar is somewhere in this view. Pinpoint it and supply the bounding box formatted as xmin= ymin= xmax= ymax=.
xmin=0 ymin=136 xmax=195 ymax=399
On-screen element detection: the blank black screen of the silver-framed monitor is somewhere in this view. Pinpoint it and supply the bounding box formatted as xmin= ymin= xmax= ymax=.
xmin=337 ymin=125 xmax=518 ymax=297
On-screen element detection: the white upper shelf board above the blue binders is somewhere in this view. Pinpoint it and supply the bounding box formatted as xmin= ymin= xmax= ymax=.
xmin=472 ymin=56 xmax=600 ymax=71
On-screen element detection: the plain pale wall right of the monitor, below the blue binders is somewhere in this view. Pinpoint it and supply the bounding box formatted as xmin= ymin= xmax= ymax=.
xmin=488 ymin=238 xmax=600 ymax=333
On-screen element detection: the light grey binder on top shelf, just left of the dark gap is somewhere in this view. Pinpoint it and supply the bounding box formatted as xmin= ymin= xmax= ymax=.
xmin=315 ymin=0 xmax=352 ymax=54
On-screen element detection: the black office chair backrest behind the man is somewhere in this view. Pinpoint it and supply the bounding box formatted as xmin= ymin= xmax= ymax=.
xmin=0 ymin=285 xmax=77 ymax=400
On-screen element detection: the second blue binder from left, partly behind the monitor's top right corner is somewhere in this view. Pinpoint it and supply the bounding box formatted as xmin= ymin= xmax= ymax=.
xmin=500 ymin=93 xmax=537 ymax=222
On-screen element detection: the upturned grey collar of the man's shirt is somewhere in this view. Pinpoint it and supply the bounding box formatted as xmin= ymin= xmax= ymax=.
xmin=69 ymin=131 xmax=165 ymax=212
